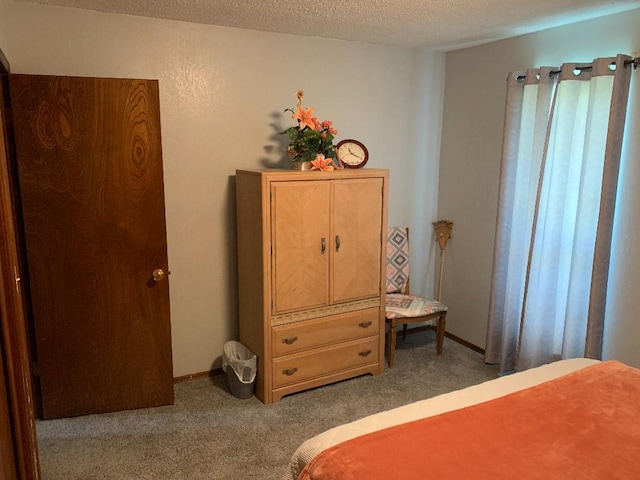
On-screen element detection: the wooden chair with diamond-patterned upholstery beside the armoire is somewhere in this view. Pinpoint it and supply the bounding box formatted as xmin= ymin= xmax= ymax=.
xmin=385 ymin=227 xmax=447 ymax=367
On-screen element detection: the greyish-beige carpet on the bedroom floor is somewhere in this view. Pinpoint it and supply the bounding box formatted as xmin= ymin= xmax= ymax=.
xmin=37 ymin=331 xmax=497 ymax=480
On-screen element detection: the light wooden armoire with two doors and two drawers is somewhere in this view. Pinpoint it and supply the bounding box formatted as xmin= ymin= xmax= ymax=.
xmin=236 ymin=169 xmax=389 ymax=403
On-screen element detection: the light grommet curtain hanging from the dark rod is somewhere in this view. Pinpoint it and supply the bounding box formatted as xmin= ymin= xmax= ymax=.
xmin=485 ymin=55 xmax=632 ymax=372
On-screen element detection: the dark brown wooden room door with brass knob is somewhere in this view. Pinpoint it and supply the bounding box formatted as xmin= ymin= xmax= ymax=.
xmin=10 ymin=75 xmax=173 ymax=418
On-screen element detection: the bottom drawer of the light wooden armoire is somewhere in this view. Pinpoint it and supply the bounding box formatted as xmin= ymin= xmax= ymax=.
xmin=273 ymin=336 xmax=379 ymax=388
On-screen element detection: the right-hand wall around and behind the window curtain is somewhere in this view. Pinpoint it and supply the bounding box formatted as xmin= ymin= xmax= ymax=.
xmin=438 ymin=10 xmax=640 ymax=366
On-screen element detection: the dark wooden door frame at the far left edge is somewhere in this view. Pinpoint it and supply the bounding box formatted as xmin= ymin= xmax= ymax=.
xmin=0 ymin=50 xmax=41 ymax=480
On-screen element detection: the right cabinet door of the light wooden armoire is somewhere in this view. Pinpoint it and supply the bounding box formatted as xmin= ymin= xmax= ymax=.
xmin=331 ymin=178 xmax=382 ymax=303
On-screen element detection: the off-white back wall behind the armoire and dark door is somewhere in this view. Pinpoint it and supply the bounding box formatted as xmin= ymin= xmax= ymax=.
xmin=0 ymin=0 xmax=444 ymax=376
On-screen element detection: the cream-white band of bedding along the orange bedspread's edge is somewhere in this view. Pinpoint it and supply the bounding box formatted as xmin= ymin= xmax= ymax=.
xmin=282 ymin=358 xmax=598 ymax=480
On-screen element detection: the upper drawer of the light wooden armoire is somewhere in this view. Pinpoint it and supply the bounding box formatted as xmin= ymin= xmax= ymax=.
xmin=272 ymin=308 xmax=380 ymax=357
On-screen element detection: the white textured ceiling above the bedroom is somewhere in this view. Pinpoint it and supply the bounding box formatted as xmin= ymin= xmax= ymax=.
xmin=19 ymin=0 xmax=640 ymax=50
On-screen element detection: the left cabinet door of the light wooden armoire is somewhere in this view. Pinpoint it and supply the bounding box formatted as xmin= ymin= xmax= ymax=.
xmin=271 ymin=181 xmax=331 ymax=314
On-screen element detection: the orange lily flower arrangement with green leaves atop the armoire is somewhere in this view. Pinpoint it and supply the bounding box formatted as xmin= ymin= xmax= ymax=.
xmin=280 ymin=90 xmax=338 ymax=170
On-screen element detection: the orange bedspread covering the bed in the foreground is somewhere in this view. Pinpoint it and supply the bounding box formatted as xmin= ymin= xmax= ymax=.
xmin=299 ymin=361 xmax=640 ymax=480
